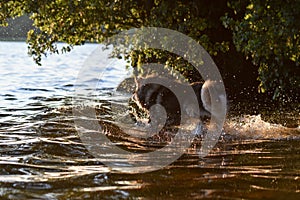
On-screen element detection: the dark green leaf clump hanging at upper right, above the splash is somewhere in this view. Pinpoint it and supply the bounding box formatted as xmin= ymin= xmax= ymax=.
xmin=223 ymin=0 xmax=300 ymax=98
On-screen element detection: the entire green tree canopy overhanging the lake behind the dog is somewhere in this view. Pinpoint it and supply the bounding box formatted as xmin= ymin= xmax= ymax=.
xmin=0 ymin=0 xmax=300 ymax=98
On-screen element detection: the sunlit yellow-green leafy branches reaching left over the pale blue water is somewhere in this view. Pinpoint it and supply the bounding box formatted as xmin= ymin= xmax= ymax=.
xmin=0 ymin=0 xmax=226 ymax=63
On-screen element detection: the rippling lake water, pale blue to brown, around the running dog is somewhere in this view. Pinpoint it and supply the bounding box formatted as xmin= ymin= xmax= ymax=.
xmin=0 ymin=42 xmax=300 ymax=199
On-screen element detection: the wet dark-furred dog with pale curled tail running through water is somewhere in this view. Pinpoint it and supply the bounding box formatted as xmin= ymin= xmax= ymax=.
xmin=131 ymin=77 xmax=210 ymax=126
